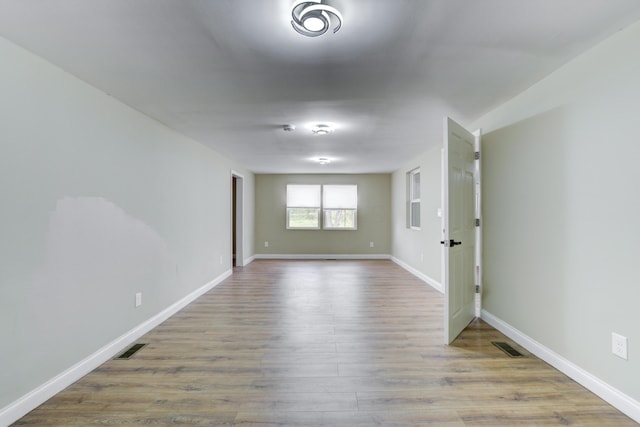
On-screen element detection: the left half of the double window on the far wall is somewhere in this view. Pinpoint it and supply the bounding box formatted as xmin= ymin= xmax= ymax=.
xmin=287 ymin=185 xmax=320 ymax=230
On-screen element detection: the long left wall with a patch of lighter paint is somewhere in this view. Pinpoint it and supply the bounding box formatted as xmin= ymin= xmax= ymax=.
xmin=0 ymin=35 xmax=253 ymax=408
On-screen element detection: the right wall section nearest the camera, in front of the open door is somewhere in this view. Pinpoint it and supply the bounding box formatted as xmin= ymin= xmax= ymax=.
xmin=476 ymin=20 xmax=640 ymax=400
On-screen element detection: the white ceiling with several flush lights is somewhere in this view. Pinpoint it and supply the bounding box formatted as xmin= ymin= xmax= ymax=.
xmin=0 ymin=0 xmax=640 ymax=173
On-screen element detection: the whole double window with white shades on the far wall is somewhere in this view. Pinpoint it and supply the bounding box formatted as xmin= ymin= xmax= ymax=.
xmin=287 ymin=184 xmax=358 ymax=230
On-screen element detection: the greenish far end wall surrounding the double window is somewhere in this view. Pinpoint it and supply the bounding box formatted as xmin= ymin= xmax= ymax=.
xmin=255 ymin=174 xmax=391 ymax=254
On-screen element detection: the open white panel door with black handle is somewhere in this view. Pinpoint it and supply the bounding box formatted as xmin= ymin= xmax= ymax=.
xmin=442 ymin=117 xmax=476 ymax=344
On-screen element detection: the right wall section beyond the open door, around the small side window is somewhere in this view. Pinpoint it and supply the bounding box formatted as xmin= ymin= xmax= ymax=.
xmin=391 ymin=145 xmax=442 ymax=283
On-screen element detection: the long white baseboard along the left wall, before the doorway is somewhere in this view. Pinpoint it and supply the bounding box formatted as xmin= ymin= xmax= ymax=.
xmin=0 ymin=270 xmax=232 ymax=426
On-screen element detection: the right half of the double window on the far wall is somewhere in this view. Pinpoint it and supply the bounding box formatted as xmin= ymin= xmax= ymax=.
xmin=322 ymin=185 xmax=358 ymax=230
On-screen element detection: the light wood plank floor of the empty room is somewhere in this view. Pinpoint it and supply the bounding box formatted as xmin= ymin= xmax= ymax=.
xmin=16 ymin=261 xmax=637 ymax=426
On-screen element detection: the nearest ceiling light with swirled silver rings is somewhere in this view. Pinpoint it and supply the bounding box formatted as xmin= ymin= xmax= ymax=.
xmin=291 ymin=0 xmax=342 ymax=37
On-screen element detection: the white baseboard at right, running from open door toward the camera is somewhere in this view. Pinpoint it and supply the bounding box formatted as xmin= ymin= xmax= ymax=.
xmin=482 ymin=310 xmax=640 ymax=423
